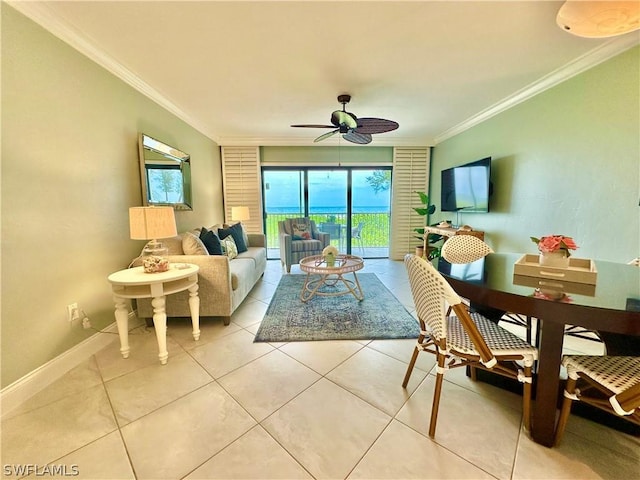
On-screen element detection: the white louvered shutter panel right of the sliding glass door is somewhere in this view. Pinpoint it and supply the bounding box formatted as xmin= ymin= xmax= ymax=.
xmin=389 ymin=147 xmax=431 ymax=260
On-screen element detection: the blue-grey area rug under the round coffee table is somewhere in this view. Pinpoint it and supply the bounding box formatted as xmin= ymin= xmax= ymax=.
xmin=254 ymin=273 xmax=420 ymax=342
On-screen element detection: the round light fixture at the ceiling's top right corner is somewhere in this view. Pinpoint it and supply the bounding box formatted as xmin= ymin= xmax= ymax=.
xmin=556 ymin=0 xmax=640 ymax=38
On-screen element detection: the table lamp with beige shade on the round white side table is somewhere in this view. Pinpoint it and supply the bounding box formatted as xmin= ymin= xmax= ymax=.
xmin=129 ymin=207 xmax=178 ymax=273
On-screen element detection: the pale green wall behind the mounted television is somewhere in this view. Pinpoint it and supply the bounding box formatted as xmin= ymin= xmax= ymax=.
xmin=430 ymin=47 xmax=640 ymax=263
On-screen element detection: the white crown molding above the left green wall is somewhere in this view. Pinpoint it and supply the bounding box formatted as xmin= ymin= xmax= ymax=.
xmin=5 ymin=0 xmax=216 ymax=141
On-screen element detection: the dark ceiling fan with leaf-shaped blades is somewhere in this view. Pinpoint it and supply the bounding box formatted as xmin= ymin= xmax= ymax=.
xmin=291 ymin=94 xmax=398 ymax=145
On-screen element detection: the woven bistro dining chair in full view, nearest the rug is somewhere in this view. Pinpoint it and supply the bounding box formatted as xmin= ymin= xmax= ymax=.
xmin=402 ymin=254 xmax=538 ymax=437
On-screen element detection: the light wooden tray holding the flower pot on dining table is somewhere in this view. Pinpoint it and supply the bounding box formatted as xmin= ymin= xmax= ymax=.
xmin=513 ymin=253 xmax=598 ymax=285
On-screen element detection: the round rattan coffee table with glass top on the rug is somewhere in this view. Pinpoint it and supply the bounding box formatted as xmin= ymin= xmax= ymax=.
xmin=300 ymin=255 xmax=364 ymax=303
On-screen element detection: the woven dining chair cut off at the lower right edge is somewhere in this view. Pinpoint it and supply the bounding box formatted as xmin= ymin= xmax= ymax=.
xmin=554 ymin=355 xmax=640 ymax=445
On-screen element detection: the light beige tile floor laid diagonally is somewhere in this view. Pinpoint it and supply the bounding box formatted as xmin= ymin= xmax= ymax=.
xmin=2 ymin=260 xmax=640 ymax=479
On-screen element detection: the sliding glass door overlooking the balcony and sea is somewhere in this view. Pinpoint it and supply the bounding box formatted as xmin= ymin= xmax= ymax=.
xmin=262 ymin=167 xmax=391 ymax=258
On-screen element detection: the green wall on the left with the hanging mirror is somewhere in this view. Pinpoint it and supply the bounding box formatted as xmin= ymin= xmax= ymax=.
xmin=0 ymin=3 xmax=223 ymax=387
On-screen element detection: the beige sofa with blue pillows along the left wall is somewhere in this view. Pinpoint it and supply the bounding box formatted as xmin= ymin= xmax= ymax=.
xmin=137 ymin=227 xmax=267 ymax=325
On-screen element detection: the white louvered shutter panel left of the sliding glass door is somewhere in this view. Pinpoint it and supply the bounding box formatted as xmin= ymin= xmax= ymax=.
xmin=222 ymin=147 xmax=263 ymax=233
